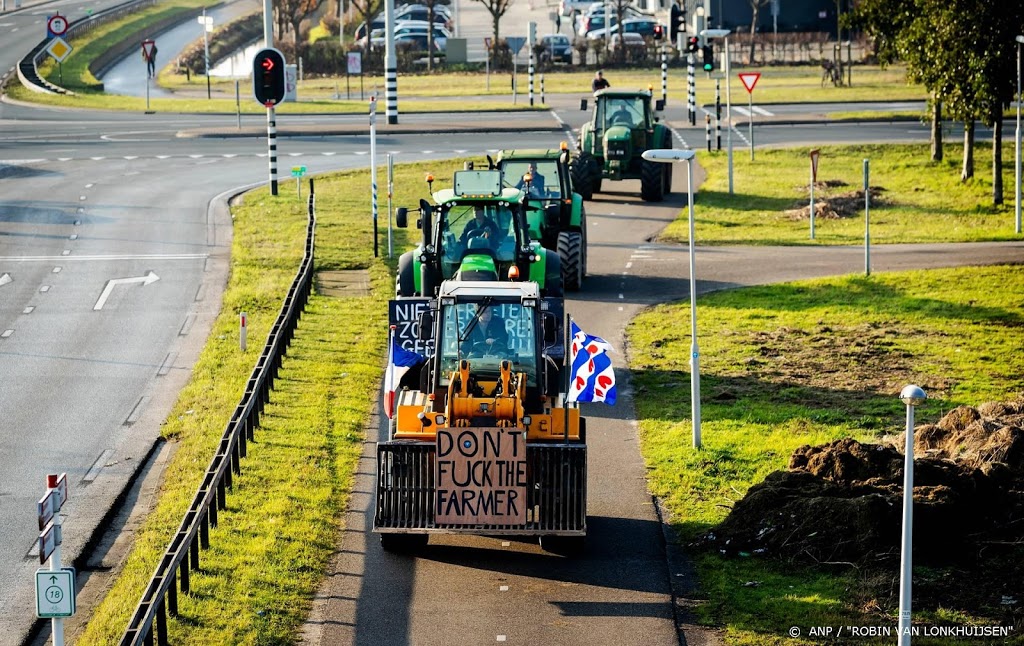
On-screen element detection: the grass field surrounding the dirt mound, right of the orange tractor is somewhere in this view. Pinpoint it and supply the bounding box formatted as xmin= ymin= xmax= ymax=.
xmin=628 ymin=265 xmax=1024 ymax=644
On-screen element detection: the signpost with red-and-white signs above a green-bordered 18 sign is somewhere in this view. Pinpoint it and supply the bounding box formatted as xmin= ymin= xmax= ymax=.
xmin=36 ymin=473 xmax=75 ymax=646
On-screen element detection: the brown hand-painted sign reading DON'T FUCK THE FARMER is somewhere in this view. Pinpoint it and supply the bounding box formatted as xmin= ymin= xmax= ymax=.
xmin=434 ymin=427 xmax=526 ymax=525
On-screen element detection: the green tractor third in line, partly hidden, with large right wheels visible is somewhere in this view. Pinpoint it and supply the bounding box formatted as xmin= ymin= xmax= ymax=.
xmin=488 ymin=143 xmax=587 ymax=291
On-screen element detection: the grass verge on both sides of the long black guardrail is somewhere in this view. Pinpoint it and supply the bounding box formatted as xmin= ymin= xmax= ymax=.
xmin=77 ymin=155 xmax=461 ymax=645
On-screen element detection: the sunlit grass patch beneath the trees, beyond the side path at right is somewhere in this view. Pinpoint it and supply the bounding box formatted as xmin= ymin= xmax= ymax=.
xmin=660 ymin=142 xmax=1019 ymax=245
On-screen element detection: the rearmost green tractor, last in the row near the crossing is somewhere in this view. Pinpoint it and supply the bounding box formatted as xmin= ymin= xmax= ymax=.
xmin=571 ymin=88 xmax=672 ymax=202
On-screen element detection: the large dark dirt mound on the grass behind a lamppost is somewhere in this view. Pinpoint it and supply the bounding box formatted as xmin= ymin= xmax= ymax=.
xmin=702 ymin=396 xmax=1024 ymax=565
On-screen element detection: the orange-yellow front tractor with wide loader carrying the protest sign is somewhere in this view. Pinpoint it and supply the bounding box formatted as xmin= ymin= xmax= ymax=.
xmin=373 ymin=279 xmax=587 ymax=555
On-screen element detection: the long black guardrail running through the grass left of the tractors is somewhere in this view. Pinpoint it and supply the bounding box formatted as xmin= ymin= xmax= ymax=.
xmin=120 ymin=179 xmax=316 ymax=646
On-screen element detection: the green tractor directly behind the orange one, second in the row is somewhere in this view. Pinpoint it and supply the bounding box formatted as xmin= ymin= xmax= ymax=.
xmin=395 ymin=170 xmax=562 ymax=297
